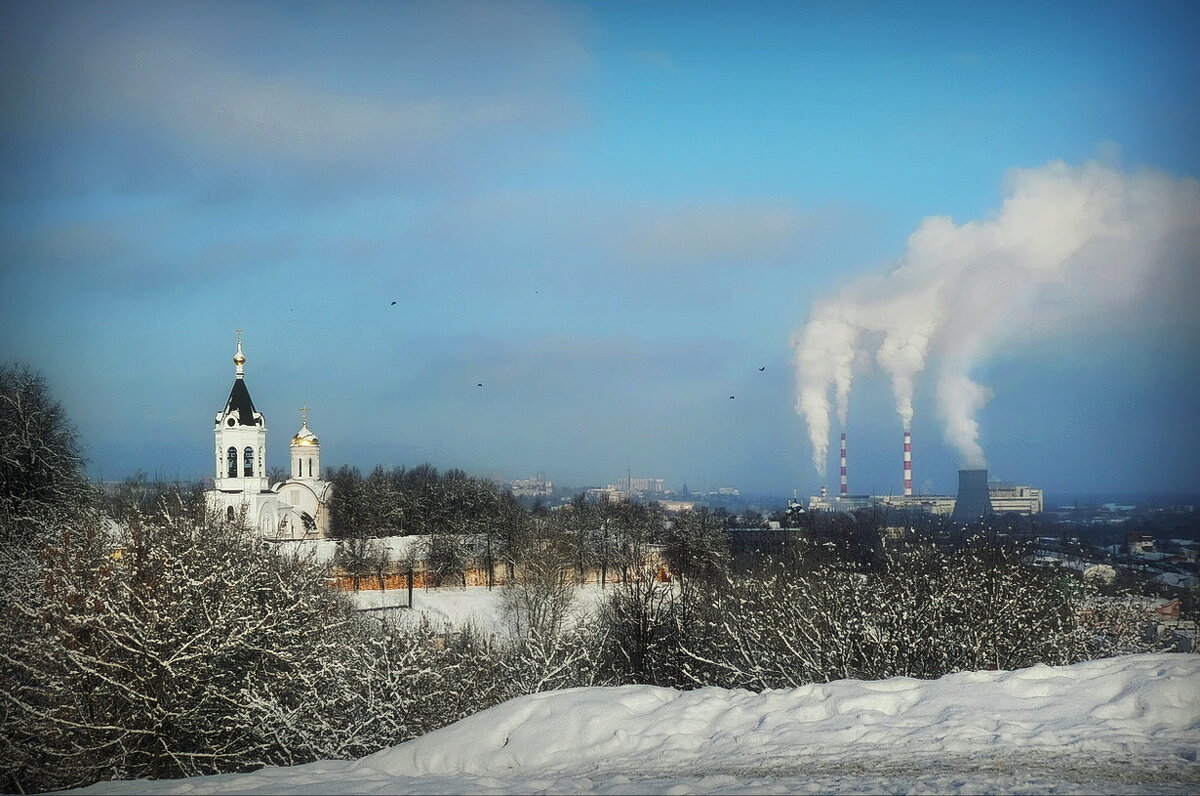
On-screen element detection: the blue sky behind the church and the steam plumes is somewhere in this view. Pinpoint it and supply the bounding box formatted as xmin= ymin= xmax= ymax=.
xmin=0 ymin=1 xmax=1200 ymax=493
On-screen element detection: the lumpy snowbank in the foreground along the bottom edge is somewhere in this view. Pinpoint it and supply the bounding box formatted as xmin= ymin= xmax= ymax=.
xmin=75 ymin=654 xmax=1200 ymax=794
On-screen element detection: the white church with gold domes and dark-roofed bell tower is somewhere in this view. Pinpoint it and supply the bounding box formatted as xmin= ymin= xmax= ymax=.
xmin=206 ymin=334 xmax=334 ymax=539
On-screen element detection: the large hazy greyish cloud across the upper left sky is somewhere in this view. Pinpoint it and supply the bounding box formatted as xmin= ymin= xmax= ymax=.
xmin=7 ymin=2 xmax=588 ymax=175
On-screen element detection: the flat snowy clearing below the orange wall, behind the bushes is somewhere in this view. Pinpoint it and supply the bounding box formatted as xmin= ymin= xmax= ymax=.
xmin=347 ymin=585 xmax=613 ymax=633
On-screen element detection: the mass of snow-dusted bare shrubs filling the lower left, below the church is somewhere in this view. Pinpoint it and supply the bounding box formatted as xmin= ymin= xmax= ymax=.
xmin=0 ymin=498 xmax=508 ymax=790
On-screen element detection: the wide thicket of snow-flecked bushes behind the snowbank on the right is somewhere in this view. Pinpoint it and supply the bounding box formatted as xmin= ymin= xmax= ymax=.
xmin=602 ymin=543 xmax=1154 ymax=690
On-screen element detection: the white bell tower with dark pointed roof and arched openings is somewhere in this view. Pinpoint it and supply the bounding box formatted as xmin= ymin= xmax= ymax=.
xmin=212 ymin=329 xmax=268 ymax=495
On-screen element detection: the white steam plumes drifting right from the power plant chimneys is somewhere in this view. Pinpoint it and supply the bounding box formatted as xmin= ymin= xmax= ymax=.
xmin=791 ymin=162 xmax=1200 ymax=475
